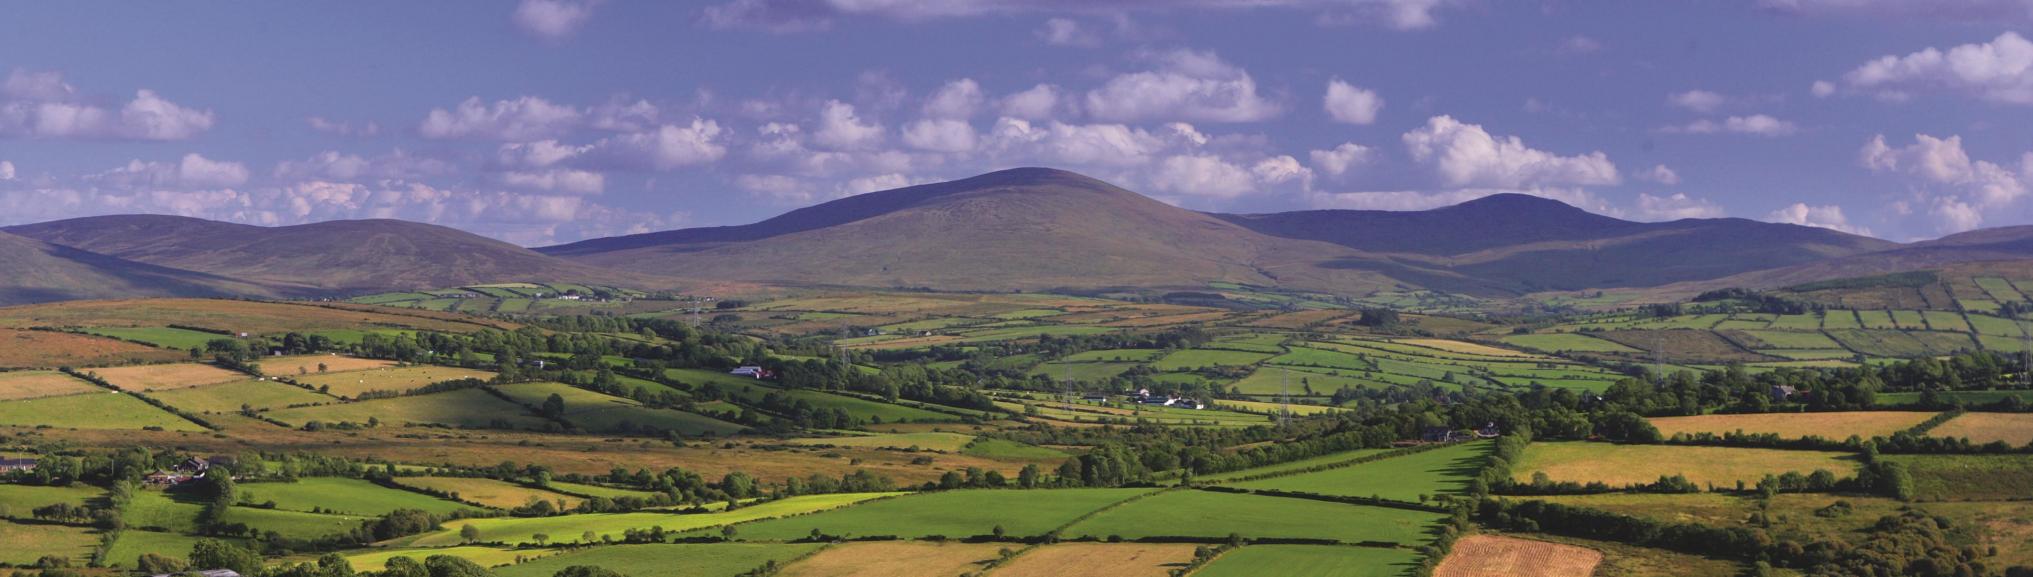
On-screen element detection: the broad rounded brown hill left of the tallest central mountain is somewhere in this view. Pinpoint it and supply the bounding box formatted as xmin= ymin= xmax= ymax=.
xmin=4 ymin=215 xmax=669 ymax=295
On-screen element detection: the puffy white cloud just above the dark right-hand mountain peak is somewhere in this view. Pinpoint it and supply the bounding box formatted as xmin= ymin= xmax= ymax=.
xmin=1403 ymin=116 xmax=1620 ymax=187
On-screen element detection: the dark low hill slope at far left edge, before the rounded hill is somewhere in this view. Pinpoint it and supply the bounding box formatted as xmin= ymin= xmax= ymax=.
xmin=0 ymin=232 xmax=272 ymax=305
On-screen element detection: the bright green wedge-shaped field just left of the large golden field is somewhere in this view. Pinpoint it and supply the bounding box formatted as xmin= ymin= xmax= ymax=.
xmin=1234 ymin=441 xmax=1490 ymax=502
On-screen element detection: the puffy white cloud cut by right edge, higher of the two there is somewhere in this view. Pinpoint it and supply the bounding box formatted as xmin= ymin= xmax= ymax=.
xmin=1842 ymin=31 xmax=2033 ymax=104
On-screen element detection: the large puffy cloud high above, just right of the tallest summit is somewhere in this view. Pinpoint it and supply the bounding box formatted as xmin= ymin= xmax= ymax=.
xmin=1086 ymin=51 xmax=1279 ymax=122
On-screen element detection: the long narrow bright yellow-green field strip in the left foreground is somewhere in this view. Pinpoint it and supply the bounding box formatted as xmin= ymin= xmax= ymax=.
xmin=409 ymin=494 xmax=895 ymax=547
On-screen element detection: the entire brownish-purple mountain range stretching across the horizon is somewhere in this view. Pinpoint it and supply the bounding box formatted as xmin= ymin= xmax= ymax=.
xmin=0 ymin=169 xmax=2033 ymax=303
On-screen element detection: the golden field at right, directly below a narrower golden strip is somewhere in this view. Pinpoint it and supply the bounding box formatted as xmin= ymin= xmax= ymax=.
xmin=1513 ymin=441 xmax=1858 ymax=488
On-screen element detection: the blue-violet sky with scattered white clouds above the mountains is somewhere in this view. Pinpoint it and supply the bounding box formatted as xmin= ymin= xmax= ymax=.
xmin=0 ymin=0 xmax=2033 ymax=246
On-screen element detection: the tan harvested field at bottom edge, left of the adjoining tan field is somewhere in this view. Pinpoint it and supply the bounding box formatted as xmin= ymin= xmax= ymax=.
xmin=777 ymin=540 xmax=1006 ymax=577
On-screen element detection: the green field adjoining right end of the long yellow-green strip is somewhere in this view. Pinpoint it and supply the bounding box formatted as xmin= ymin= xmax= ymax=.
xmin=740 ymin=490 xmax=1151 ymax=540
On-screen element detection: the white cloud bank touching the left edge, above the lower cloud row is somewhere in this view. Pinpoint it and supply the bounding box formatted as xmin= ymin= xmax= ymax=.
xmin=0 ymin=69 xmax=213 ymax=140
